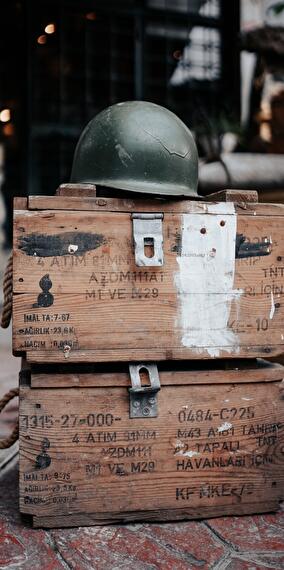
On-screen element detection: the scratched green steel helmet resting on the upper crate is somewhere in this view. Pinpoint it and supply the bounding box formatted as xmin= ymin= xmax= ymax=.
xmin=71 ymin=101 xmax=198 ymax=197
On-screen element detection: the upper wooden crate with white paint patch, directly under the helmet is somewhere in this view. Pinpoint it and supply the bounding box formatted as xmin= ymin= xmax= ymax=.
xmin=13 ymin=189 xmax=284 ymax=362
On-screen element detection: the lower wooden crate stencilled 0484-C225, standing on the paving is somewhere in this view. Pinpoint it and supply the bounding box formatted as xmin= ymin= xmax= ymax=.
xmin=20 ymin=361 xmax=284 ymax=527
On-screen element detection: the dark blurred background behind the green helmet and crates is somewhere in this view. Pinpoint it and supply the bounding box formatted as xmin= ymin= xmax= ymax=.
xmin=0 ymin=0 xmax=284 ymax=258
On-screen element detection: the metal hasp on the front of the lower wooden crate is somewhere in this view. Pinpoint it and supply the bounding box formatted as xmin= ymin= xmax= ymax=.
xmin=129 ymin=364 xmax=161 ymax=418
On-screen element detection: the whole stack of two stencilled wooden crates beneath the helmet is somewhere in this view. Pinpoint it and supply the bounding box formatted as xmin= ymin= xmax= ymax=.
xmin=13 ymin=185 xmax=284 ymax=526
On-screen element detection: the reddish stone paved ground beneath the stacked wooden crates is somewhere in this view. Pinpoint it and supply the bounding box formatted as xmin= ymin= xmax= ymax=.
xmin=0 ymin=197 xmax=284 ymax=570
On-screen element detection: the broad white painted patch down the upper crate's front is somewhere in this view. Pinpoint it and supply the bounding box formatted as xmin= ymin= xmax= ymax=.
xmin=175 ymin=202 xmax=242 ymax=357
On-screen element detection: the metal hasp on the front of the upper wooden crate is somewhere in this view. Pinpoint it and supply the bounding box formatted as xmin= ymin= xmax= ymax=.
xmin=131 ymin=213 xmax=164 ymax=267
